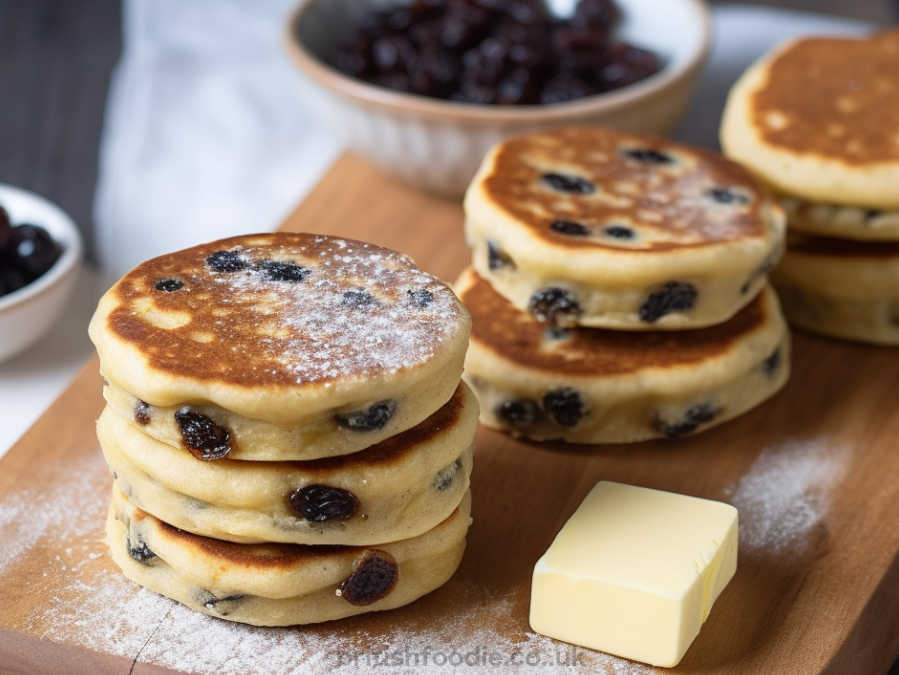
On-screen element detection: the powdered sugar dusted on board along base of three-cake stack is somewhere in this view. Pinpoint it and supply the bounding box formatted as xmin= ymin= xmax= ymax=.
xmin=29 ymin=571 xmax=654 ymax=675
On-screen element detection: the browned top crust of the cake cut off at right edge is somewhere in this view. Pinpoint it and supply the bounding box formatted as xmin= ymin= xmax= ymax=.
xmin=750 ymin=30 xmax=899 ymax=165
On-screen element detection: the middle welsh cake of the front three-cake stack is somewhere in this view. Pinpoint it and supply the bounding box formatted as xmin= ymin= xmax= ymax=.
xmin=97 ymin=384 xmax=478 ymax=545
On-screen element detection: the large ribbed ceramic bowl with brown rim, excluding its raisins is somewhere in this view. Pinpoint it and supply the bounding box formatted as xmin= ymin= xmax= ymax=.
xmin=286 ymin=0 xmax=710 ymax=196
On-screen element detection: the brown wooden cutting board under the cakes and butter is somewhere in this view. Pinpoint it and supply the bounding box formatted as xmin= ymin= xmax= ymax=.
xmin=0 ymin=156 xmax=899 ymax=674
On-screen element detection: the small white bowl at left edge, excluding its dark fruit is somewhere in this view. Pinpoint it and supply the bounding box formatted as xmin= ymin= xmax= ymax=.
xmin=0 ymin=183 xmax=82 ymax=361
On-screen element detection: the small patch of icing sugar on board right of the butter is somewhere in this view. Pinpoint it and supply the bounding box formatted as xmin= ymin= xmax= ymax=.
xmin=725 ymin=441 xmax=845 ymax=555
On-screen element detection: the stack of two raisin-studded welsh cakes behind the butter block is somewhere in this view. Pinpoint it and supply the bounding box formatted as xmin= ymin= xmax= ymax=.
xmin=456 ymin=129 xmax=789 ymax=443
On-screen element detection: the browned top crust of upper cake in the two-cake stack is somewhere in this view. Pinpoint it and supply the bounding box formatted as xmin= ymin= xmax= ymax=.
xmin=482 ymin=128 xmax=769 ymax=252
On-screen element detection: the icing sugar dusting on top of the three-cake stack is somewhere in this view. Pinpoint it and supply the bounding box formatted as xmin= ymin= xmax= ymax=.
xmin=215 ymin=241 xmax=460 ymax=382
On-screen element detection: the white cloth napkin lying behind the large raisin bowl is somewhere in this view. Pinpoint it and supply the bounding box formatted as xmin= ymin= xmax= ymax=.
xmin=95 ymin=0 xmax=863 ymax=281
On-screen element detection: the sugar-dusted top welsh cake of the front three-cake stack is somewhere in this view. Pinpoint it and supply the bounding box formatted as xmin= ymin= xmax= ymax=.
xmin=90 ymin=233 xmax=469 ymax=460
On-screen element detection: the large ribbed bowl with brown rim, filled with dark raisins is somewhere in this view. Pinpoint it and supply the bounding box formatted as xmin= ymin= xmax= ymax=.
xmin=286 ymin=0 xmax=710 ymax=197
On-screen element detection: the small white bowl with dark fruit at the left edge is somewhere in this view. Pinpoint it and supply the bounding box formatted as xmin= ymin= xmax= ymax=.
xmin=0 ymin=184 xmax=81 ymax=360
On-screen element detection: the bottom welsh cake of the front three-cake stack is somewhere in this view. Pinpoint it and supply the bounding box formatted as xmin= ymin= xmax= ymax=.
xmin=106 ymin=488 xmax=471 ymax=626
